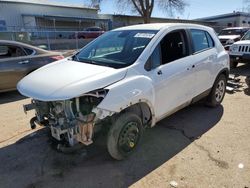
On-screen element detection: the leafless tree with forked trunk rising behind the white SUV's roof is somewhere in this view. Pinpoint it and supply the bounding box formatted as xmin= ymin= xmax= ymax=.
xmin=87 ymin=0 xmax=187 ymax=23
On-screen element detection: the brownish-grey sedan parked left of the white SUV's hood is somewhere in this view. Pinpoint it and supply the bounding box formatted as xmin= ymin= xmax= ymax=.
xmin=0 ymin=40 xmax=64 ymax=92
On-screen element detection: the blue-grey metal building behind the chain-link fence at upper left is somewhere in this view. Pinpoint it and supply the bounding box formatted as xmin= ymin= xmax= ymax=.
xmin=0 ymin=0 xmax=109 ymax=31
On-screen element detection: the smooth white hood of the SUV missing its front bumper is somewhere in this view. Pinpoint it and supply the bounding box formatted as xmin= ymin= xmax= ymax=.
xmin=17 ymin=59 xmax=127 ymax=101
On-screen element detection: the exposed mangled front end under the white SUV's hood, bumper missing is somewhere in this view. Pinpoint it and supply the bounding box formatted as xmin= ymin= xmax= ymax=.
xmin=24 ymin=89 xmax=111 ymax=146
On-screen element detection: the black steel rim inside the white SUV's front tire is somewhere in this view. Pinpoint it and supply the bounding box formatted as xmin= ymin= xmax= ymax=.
xmin=118 ymin=122 xmax=140 ymax=154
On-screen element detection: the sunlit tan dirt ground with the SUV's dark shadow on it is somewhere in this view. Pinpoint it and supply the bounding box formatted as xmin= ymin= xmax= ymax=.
xmin=0 ymin=65 xmax=250 ymax=188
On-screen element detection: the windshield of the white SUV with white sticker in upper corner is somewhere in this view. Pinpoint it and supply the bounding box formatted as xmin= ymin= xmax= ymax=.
xmin=73 ymin=30 xmax=157 ymax=68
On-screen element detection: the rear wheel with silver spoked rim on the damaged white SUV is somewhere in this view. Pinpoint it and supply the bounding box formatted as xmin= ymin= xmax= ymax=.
xmin=206 ymin=74 xmax=227 ymax=107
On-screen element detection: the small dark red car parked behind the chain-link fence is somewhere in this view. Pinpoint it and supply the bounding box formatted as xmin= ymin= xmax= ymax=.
xmin=76 ymin=27 xmax=105 ymax=39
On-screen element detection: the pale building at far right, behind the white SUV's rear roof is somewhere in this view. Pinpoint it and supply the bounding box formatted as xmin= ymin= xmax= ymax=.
xmin=196 ymin=12 xmax=250 ymax=32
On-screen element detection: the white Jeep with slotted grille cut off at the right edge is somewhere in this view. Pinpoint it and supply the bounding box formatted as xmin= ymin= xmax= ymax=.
xmin=229 ymin=31 xmax=250 ymax=68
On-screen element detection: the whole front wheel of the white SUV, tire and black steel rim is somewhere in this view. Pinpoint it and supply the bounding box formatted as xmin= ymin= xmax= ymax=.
xmin=107 ymin=112 xmax=143 ymax=160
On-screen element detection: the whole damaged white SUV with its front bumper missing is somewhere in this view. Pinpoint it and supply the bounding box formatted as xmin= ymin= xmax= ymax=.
xmin=17 ymin=23 xmax=229 ymax=160
